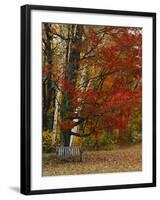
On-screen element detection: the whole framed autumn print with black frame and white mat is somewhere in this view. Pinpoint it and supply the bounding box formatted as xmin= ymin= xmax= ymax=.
xmin=21 ymin=5 xmax=156 ymax=194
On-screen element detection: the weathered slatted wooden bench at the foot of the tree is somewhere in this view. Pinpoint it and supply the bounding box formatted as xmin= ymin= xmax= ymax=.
xmin=56 ymin=146 xmax=83 ymax=162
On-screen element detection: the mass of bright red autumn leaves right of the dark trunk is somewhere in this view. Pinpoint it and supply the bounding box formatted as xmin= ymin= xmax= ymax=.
xmin=61 ymin=27 xmax=142 ymax=135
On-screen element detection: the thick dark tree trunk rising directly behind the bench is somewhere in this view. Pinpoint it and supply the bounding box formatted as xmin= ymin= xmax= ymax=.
xmin=60 ymin=25 xmax=83 ymax=146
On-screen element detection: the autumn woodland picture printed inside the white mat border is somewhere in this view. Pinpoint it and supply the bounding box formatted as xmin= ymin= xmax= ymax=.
xmin=42 ymin=23 xmax=142 ymax=176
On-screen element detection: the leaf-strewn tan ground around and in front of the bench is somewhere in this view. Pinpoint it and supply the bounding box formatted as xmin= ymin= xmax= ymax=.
xmin=42 ymin=144 xmax=142 ymax=176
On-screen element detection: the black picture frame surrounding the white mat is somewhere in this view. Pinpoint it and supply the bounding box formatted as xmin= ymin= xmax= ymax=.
xmin=21 ymin=5 xmax=156 ymax=195
